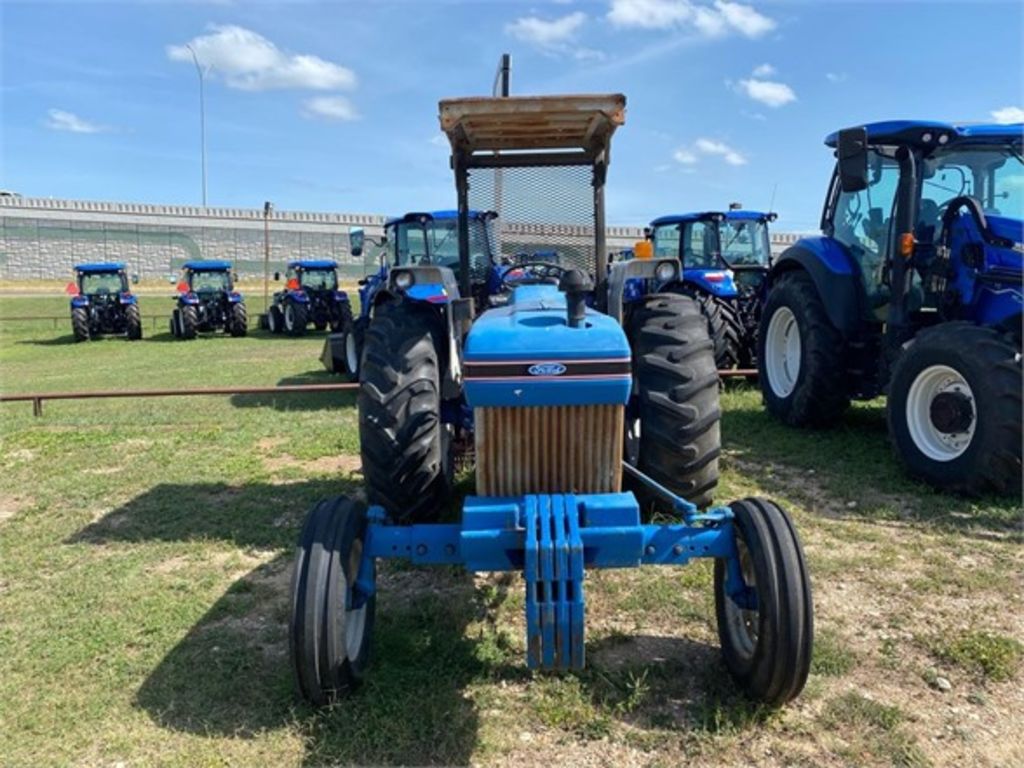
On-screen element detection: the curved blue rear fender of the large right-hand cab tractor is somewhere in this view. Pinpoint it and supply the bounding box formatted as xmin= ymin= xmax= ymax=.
xmin=768 ymin=237 xmax=866 ymax=337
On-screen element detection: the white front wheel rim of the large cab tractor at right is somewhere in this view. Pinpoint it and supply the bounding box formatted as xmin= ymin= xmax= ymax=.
xmin=906 ymin=366 xmax=978 ymax=462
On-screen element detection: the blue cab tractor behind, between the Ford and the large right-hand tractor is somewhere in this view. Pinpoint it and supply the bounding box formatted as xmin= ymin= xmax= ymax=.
xmin=648 ymin=209 xmax=776 ymax=370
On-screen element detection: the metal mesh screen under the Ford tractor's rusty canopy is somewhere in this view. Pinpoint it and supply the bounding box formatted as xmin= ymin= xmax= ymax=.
xmin=468 ymin=161 xmax=597 ymax=282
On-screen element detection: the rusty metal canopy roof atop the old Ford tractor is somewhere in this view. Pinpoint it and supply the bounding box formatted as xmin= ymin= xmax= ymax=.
xmin=439 ymin=93 xmax=626 ymax=155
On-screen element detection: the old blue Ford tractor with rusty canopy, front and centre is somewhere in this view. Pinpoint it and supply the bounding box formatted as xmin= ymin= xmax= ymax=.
xmin=289 ymin=95 xmax=813 ymax=705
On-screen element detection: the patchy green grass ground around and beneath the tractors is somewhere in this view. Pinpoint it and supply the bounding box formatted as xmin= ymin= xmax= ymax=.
xmin=0 ymin=297 xmax=1021 ymax=766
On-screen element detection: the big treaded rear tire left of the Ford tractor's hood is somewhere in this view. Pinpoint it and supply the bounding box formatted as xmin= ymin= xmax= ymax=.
xmin=358 ymin=301 xmax=452 ymax=522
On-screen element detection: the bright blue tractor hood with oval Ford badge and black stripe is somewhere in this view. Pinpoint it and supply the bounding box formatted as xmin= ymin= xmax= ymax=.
xmin=463 ymin=285 xmax=632 ymax=408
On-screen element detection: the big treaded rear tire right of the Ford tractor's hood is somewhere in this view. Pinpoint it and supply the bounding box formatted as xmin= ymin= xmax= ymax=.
xmin=626 ymin=293 xmax=722 ymax=508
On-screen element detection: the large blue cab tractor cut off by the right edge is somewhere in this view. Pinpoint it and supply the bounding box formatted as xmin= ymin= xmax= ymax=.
xmin=758 ymin=121 xmax=1024 ymax=495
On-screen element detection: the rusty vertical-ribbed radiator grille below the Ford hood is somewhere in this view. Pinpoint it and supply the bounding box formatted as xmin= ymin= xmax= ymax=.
xmin=474 ymin=406 xmax=623 ymax=496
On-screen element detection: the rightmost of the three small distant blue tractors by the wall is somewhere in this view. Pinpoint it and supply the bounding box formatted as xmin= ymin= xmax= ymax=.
xmin=266 ymin=259 xmax=352 ymax=336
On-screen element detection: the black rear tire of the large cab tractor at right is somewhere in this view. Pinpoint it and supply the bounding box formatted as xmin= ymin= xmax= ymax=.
xmin=758 ymin=270 xmax=850 ymax=427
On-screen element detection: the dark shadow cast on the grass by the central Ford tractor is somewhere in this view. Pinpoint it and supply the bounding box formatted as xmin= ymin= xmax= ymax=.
xmin=67 ymin=480 xmax=507 ymax=765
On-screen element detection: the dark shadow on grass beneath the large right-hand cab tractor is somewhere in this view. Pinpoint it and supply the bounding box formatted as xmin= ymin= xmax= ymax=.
xmin=722 ymin=393 xmax=1022 ymax=539
